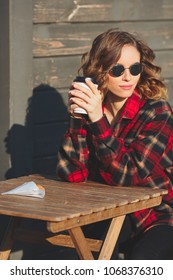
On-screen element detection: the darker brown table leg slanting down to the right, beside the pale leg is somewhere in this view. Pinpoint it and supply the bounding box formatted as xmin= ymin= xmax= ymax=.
xmin=69 ymin=227 xmax=94 ymax=260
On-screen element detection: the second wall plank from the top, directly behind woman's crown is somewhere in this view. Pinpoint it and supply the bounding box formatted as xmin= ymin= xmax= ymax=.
xmin=33 ymin=21 xmax=173 ymax=57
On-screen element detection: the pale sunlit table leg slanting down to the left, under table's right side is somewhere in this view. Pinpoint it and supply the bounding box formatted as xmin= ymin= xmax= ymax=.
xmin=98 ymin=215 xmax=125 ymax=260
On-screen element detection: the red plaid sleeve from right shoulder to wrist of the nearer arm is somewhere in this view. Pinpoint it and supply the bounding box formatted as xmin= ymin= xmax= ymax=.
xmin=89 ymin=108 xmax=173 ymax=186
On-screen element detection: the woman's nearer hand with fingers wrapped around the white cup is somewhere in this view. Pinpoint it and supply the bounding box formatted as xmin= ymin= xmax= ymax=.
xmin=70 ymin=78 xmax=103 ymax=122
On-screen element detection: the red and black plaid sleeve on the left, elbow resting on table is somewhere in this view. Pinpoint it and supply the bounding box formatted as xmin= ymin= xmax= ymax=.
xmin=57 ymin=117 xmax=88 ymax=182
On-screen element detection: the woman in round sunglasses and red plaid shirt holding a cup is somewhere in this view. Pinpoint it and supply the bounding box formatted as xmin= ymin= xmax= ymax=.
xmin=57 ymin=29 xmax=173 ymax=259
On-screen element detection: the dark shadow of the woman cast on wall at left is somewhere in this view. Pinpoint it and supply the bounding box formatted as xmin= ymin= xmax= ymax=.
xmin=4 ymin=84 xmax=68 ymax=179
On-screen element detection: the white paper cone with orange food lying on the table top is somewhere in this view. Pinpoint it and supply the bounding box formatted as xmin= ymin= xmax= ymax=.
xmin=1 ymin=181 xmax=45 ymax=198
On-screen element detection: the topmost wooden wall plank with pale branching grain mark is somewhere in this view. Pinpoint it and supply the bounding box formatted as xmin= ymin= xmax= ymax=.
xmin=33 ymin=0 xmax=173 ymax=23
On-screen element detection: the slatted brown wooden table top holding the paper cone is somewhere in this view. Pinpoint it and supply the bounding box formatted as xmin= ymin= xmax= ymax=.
xmin=0 ymin=175 xmax=167 ymax=225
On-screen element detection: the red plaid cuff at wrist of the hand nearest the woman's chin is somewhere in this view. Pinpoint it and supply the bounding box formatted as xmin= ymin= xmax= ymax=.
xmin=89 ymin=115 xmax=111 ymax=138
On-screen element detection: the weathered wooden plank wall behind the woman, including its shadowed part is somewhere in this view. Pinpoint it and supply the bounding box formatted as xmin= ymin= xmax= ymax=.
xmin=31 ymin=0 xmax=173 ymax=173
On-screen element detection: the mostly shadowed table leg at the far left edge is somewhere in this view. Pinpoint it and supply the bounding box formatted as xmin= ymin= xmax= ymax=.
xmin=0 ymin=217 xmax=19 ymax=260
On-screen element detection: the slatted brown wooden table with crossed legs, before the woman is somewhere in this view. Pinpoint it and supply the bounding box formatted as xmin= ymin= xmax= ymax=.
xmin=0 ymin=175 xmax=167 ymax=260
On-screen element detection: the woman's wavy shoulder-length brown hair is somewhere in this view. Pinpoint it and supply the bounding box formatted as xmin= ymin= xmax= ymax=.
xmin=78 ymin=29 xmax=167 ymax=100
